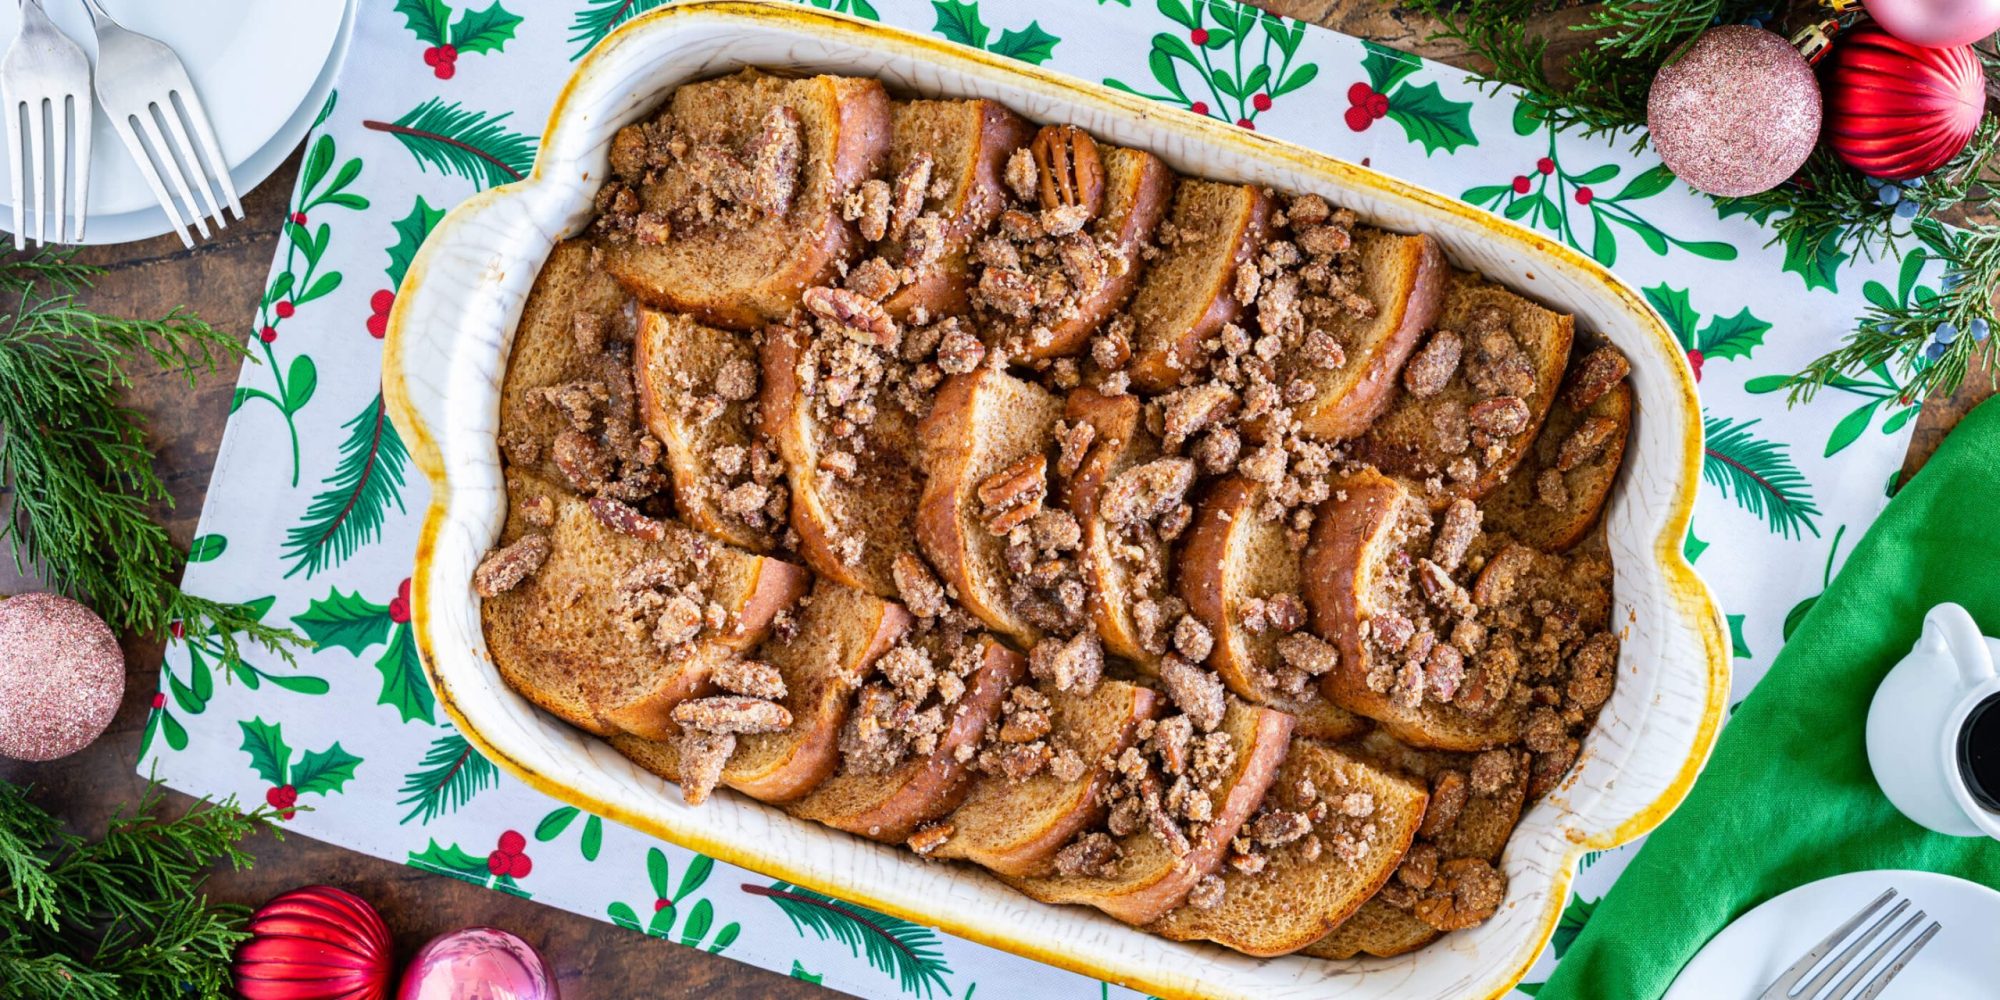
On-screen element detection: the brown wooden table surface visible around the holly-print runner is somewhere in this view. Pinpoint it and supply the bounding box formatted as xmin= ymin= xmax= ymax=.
xmin=0 ymin=0 xmax=1992 ymax=1000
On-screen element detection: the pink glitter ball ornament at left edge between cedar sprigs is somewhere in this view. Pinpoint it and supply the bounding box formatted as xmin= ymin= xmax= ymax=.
xmin=0 ymin=594 xmax=124 ymax=760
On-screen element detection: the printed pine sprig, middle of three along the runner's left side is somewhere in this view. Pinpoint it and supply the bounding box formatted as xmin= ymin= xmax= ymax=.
xmin=284 ymin=392 xmax=410 ymax=578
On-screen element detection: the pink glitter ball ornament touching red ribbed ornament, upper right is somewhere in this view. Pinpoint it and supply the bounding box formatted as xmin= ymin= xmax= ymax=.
xmin=1646 ymin=24 xmax=1820 ymax=198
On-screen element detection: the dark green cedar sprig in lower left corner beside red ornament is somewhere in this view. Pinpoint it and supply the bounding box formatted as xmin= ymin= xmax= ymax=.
xmin=0 ymin=782 xmax=282 ymax=1000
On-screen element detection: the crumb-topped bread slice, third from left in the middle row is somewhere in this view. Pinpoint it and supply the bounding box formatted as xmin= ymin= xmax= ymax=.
xmin=758 ymin=326 xmax=922 ymax=598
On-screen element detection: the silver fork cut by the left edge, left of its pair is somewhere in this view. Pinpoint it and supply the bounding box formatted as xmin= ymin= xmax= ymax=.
xmin=0 ymin=0 xmax=94 ymax=250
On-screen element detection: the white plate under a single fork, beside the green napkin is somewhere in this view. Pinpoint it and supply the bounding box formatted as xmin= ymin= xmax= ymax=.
xmin=1660 ymin=870 xmax=2000 ymax=1000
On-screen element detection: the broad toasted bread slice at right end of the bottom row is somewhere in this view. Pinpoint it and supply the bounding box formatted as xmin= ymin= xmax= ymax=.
xmin=1148 ymin=740 xmax=1430 ymax=958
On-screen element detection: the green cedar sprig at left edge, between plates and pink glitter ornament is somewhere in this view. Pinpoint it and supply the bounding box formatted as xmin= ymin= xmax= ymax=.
xmin=0 ymin=250 xmax=304 ymax=660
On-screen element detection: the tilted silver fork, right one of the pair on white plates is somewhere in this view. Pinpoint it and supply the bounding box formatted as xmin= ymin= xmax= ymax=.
xmin=84 ymin=0 xmax=244 ymax=246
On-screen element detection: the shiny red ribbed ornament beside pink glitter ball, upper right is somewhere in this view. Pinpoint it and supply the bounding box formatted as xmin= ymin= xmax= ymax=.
xmin=1820 ymin=24 xmax=1986 ymax=180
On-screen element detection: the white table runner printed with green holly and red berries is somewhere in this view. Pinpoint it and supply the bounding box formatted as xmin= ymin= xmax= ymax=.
xmin=140 ymin=0 xmax=1938 ymax=1000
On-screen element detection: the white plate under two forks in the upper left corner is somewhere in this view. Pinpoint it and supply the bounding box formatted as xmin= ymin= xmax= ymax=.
xmin=0 ymin=0 xmax=354 ymax=244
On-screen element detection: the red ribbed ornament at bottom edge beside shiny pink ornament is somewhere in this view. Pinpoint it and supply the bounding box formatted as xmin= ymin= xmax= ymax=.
xmin=236 ymin=886 xmax=394 ymax=1000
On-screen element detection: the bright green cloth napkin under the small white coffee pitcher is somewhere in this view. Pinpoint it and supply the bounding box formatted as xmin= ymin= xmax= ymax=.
xmin=1536 ymin=400 xmax=2000 ymax=1000
